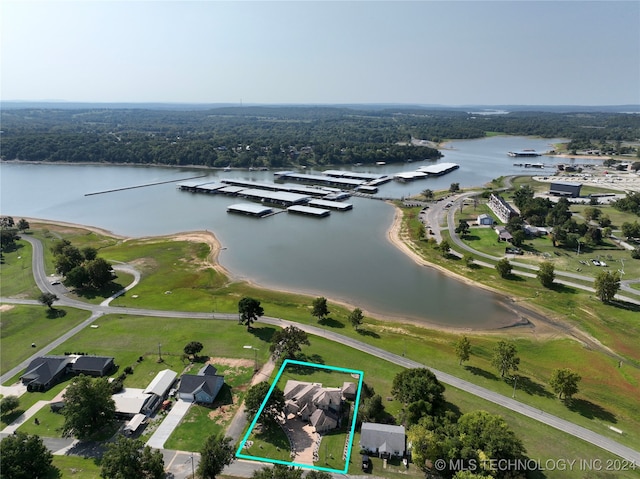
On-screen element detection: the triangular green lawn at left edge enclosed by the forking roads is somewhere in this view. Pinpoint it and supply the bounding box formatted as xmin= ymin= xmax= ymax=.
xmin=0 ymin=303 xmax=89 ymax=374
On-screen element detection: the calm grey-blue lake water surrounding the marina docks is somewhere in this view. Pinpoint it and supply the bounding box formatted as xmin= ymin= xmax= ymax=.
xmin=0 ymin=137 xmax=580 ymax=328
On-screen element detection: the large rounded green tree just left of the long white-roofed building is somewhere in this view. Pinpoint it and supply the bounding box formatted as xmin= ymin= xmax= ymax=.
xmin=62 ymin=375 xmax=116 ymax=439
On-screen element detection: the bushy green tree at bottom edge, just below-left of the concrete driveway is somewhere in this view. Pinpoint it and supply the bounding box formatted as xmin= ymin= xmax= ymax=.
xmin=100 ymin=436 xmax=165 ymax=479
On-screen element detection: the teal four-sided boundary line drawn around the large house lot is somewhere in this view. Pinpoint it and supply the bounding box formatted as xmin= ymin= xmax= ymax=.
xmin=236 ymin=359 xmax=364 ymax=474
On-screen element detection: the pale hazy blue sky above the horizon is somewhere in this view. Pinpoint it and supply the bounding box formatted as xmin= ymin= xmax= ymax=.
xmin=0 ymin=0 xmax=640 ymax=106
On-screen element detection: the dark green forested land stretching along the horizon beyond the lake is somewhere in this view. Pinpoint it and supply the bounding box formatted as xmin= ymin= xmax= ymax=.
xmin=0 ymin=106 xmax=640 ymax=168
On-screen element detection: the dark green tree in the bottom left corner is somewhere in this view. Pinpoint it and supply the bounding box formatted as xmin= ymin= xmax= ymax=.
xmin=0 ymin=431 xmax=58 ymax=479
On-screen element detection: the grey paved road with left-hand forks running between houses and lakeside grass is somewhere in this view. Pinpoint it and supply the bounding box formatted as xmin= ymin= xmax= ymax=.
xmin=0 ymin=236 xmax=640 ymax=465
